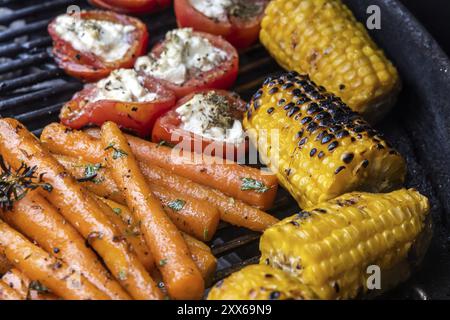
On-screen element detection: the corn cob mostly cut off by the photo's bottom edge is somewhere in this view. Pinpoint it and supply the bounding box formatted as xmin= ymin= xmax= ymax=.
xmin=208 ymin=265 xmax=315 ymax=300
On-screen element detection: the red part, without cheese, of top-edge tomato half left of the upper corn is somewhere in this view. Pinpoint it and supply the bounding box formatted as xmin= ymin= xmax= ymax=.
xmin=174 ymin=0 xmax=269 ymax=49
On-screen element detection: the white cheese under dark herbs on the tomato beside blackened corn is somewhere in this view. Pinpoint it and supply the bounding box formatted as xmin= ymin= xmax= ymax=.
xmin=175 ymin=92 xmax=245 ymax=144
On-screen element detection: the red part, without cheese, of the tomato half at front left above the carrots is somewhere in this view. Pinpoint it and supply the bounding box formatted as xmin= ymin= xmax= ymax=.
xmin=59 ymin=81 xmax=176 ymax=137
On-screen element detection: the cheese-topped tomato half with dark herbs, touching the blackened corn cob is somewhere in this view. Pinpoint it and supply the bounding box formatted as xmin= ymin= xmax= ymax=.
xmin=152 ymin=90 xmax=248 ymax=160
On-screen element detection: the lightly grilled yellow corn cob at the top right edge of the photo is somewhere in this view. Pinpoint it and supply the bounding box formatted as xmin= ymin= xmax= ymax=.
xmin=260 ymin=0 xmax=400 ymax=123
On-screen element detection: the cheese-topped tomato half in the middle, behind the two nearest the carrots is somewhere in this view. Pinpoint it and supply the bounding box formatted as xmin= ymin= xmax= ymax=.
xmin=135 ymin=28 xmax=239 ymax=98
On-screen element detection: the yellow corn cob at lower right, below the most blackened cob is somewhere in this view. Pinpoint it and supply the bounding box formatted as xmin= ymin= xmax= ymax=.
xmin=260 ymin=189 xmax=431 ymax=299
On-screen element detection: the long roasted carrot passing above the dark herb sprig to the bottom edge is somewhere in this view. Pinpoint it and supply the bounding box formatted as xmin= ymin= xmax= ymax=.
xmin=0 ymin=118 xmax=163 ymax=299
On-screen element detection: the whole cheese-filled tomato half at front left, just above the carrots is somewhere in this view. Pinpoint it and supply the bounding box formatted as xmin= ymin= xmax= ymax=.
xmin=60 ymin=69 xmax=175 ymax=137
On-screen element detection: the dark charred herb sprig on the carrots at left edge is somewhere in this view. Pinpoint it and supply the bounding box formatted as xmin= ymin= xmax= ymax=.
xmin=0 ymin=155 xmax=53 ymax=211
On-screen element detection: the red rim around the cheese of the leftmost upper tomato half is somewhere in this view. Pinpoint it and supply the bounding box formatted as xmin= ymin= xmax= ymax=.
xmin=48 ymin=11 xmax=148 ymax=82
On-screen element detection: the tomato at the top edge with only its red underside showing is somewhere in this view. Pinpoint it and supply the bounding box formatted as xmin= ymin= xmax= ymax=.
xmin=90 ymin=0 xmax=172 ymax=14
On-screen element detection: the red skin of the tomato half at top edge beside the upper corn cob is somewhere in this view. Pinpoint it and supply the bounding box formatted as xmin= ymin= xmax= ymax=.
xmin=174 ymin=0 xmax=268 ymax=49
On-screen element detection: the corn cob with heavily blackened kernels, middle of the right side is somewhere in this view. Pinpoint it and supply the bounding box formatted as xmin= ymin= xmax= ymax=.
xmin=244 ymin=72 xmax=406 ymax=208
